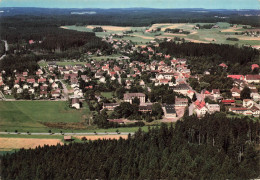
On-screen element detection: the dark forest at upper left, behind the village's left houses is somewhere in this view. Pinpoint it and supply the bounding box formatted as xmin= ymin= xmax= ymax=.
xmin=0 ymin=16 xmax=108 ymax=52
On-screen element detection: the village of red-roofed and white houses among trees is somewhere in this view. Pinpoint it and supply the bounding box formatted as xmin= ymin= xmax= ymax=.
xmin=0 ymin=34 xmax=260 ymax=123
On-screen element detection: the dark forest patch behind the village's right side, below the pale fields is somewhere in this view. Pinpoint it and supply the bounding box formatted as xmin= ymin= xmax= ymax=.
xmin=160 ymin=42 xmax=259 ymax=74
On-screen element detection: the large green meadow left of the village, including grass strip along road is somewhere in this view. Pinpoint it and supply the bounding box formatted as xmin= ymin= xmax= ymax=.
xmin=0 ymin=102 xmax=152 ymax=133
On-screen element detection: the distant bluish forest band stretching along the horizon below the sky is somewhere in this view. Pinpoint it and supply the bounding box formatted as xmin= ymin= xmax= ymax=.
xmin=0 ymin=8 xmax=260 ymax=27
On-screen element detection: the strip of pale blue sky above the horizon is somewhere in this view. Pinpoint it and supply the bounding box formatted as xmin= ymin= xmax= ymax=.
xmin=0 ymin=0 xmax=260 ymax=9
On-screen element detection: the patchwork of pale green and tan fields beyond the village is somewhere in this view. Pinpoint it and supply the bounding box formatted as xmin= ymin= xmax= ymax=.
xmin=63 ymin=22 xmax=260 ymax=46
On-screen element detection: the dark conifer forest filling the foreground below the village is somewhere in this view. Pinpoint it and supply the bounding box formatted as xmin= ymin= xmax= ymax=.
xmin=1 ymin=113 xmax=260 ymax=179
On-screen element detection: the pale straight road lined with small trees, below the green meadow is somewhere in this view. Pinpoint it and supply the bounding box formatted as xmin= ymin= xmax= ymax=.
xmin=0 ymin=132 xmax=134 ymax=135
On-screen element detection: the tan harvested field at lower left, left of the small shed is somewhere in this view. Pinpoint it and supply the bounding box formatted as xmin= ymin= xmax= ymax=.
xmin=0 ymin=138 xmax=63 ymax=151
